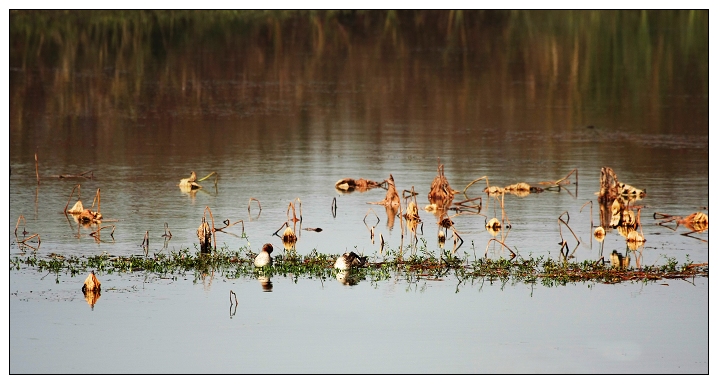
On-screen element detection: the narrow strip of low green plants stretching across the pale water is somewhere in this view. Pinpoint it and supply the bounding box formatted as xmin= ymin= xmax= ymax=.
xmin=10 ymin=243 xmax=708 ymax=289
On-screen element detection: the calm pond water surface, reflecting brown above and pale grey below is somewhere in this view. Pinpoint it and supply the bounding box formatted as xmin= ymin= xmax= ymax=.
xmin=6 ymin=12 xmax=709 ymax=373
